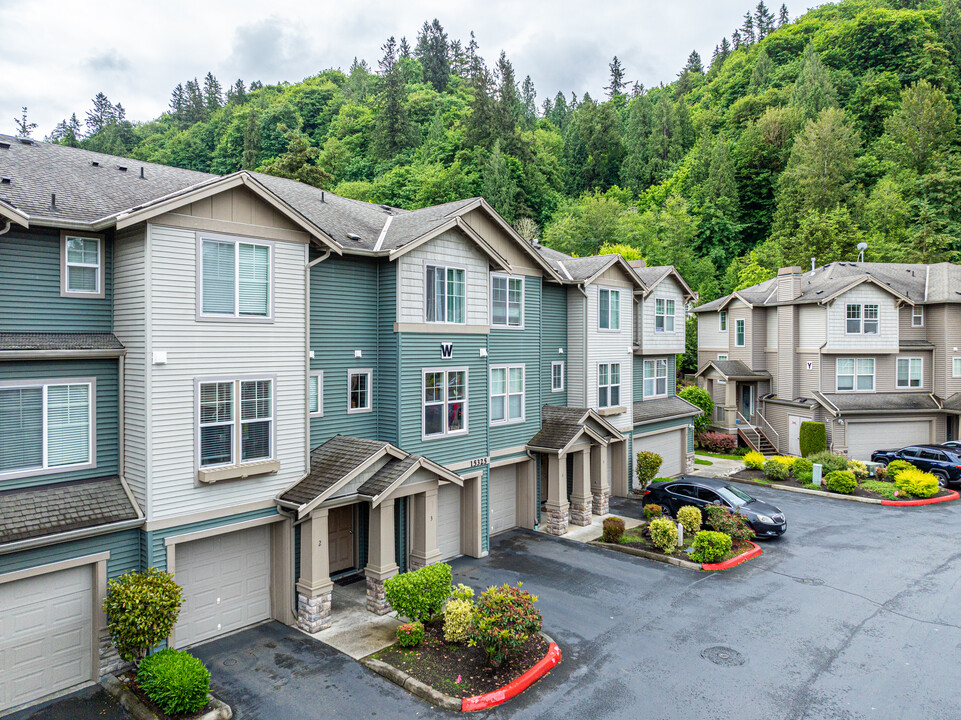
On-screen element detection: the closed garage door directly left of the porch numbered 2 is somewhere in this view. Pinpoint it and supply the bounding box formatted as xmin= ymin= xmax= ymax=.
xmin=174 ymin=526 xmax=270 ymax=647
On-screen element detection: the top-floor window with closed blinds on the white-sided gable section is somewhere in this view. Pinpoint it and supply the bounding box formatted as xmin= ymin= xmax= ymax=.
xmin=200 ymin=238 xmax=272 ymax=319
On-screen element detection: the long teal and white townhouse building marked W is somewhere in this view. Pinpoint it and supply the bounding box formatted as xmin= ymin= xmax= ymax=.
xmin=0 ymin=136 xmax=698 ymax=711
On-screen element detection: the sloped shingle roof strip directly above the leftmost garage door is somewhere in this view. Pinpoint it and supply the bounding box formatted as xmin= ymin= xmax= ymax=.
xmin=0 ymin=476 xmax=137 ymax=545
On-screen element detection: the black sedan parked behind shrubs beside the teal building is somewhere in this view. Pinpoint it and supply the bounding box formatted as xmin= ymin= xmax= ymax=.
xmin=644 ymin=475 xmax=787 ymax=538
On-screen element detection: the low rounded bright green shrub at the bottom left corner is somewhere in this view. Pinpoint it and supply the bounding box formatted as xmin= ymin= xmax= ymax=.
xmin=137 ymin=648 xmax=210 ymax=715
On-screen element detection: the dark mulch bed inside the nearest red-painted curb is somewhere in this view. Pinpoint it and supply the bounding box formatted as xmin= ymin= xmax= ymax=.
xmin=374 ymin=621 xmax=549 ymax=698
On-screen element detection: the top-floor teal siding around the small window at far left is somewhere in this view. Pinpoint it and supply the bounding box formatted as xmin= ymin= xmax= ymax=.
xmin=0 ymin=228 xmax=113 ymax=332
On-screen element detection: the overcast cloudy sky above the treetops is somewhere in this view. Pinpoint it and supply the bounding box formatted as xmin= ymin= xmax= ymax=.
xmin=0 ymin=0 xmax=760 ymax=137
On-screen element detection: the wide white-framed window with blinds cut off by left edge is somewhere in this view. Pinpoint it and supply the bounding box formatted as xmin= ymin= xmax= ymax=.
xmin=0 ymin=380 xmax=96 ymax=477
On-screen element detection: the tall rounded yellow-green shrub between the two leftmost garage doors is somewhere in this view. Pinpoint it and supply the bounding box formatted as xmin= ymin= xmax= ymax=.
xmin=102 ymin=568 xmax=183 ymax=663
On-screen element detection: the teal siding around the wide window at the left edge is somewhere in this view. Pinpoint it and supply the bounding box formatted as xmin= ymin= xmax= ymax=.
xmin=0 ymin=358 xmax=119 ymax=490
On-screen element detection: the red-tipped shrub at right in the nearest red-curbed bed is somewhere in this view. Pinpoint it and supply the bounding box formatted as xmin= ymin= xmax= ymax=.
xmin=469 ymin=584 xmax=541 ymax=667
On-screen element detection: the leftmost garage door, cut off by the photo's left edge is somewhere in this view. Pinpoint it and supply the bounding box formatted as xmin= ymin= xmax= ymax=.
xmin=0 ymin=565 xmax=94 ymax=712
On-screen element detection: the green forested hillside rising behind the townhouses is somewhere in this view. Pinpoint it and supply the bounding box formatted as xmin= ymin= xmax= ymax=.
xmin=41 ymin=0 xmax=961 ymax=300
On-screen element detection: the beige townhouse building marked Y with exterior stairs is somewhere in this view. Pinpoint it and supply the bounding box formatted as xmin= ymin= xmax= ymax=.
xmin=694 ymin=262 xmax=961 ymax=460
